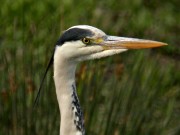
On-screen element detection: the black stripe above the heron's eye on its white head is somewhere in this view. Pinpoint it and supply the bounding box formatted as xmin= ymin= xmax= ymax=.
xmin=56 ymin=28 xmax=94 ymax=45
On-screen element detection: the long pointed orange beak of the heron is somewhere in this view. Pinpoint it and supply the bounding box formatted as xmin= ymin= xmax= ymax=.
xmin=100 ymin=36 xmax=167 ymax=50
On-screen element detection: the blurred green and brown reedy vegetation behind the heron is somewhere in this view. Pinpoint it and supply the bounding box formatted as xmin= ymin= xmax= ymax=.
xmin=0 ymin=0 xmax=180 ymax=135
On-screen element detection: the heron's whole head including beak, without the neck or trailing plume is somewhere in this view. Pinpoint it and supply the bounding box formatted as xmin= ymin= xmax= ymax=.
xmin=55 ymin=25 xmax=167 ymax=61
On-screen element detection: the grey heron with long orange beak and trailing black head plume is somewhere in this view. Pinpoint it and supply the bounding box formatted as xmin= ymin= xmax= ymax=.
xmin=35 ymin=25 xmax=167 ymax=135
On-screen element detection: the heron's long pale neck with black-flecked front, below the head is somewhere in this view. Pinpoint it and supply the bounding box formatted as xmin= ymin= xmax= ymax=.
xmin=54 ymin=59 xmax=84 ymax=135
